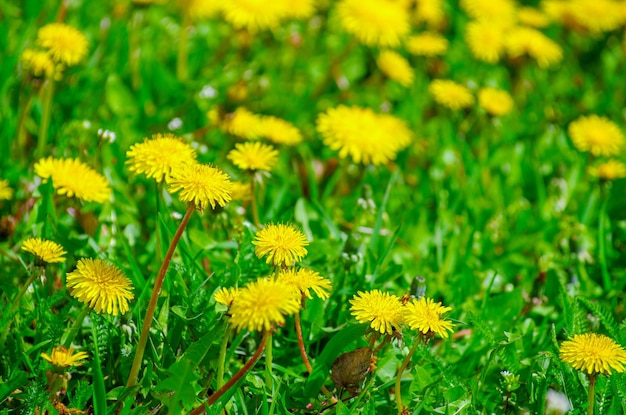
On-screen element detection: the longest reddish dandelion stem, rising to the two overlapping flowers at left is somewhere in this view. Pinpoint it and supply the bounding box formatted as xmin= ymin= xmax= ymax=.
xmin=126 ymin=203 xmax=196 ymax=388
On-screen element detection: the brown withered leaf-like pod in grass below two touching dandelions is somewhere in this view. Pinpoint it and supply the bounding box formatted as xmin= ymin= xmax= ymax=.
xmin=330 ymin=347 xmax=372 ymax=394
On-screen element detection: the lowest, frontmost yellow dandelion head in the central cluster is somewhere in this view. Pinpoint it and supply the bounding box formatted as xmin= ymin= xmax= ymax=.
xmin=230 ymin=278 xmax=300 ymax=331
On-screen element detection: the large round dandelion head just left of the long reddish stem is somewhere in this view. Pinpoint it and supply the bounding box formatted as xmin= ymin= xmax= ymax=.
xmin=66 ymin=258 xmax=134 ymax=316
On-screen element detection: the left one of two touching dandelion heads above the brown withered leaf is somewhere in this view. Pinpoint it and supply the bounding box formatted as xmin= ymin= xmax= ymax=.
xmin=350 ymin=290 xmax=403 ymax=335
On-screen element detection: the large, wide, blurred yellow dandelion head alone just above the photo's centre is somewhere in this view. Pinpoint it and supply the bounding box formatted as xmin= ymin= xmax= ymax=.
xmin=317 ymin=105 xmax=412 ymax=165
